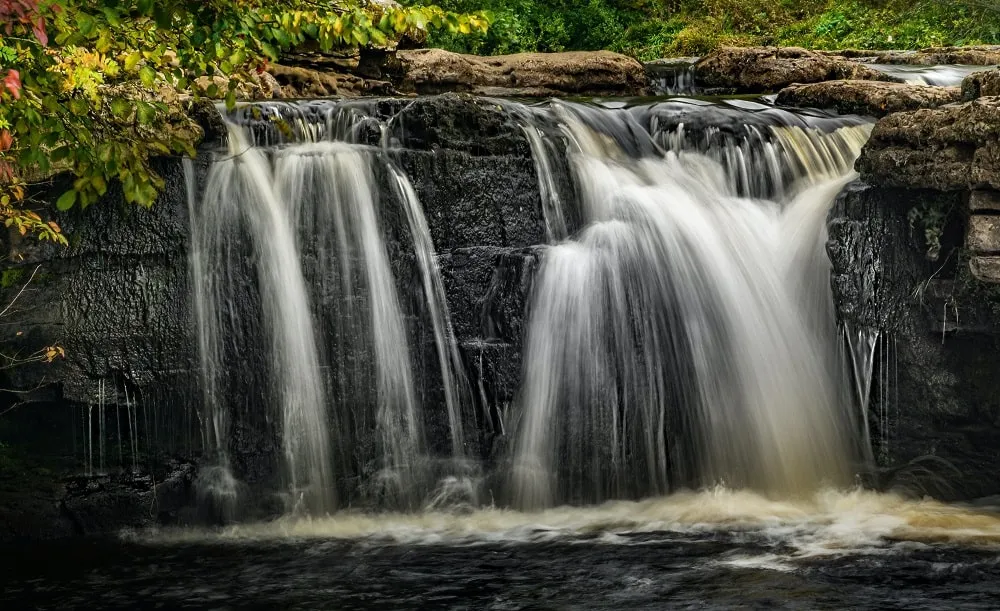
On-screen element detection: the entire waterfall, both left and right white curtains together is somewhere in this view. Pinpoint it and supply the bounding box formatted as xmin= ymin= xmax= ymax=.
xmin=189 ymin=99 xmax=871 ymax=521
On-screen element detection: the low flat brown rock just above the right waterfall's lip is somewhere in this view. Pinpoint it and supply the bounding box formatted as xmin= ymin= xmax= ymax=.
xmin=777 ymin=80 xmax=961 ymax=117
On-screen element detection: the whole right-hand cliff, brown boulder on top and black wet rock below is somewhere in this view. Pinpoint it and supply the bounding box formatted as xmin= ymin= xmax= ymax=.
xmin=830 ymin=87 xmax=1000 ymax=498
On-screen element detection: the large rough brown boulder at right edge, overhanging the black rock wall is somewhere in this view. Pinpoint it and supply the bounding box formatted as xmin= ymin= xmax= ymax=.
xmin=856 ymin=97 xmax=1000 ymax=191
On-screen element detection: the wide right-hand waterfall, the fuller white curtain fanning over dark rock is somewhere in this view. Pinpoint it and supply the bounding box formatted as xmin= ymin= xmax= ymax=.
xmin=510 ymin=106 xmax=869 ymax=508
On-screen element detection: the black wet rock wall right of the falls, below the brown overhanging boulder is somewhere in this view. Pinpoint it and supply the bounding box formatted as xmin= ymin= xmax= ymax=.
xmin=828 ymin=183 xmax=1000 ymax=499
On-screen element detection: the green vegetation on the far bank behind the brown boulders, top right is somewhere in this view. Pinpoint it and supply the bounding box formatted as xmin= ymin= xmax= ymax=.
xmin=404 ymin=0 xmax=1000 ymax=60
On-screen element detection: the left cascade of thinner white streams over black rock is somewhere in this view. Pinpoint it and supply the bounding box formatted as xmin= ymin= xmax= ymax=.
xmin=189 ymin=104 xmax=469 ymax=518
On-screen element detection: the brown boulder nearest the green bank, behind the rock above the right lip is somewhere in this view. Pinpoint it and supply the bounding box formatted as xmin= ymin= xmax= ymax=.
xmin=694 ymin=47 xmax=896 ymax=93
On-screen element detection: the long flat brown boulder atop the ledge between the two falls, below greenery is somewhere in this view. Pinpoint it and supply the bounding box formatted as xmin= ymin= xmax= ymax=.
xmin=398 ymin=49 xmax=649 ymax=97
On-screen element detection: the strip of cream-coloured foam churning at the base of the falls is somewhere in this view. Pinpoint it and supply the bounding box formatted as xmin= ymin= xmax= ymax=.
xmin=139 ymin=488 xmax=1000 ymax=563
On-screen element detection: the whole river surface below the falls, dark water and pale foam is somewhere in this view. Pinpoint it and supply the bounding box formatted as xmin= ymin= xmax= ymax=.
xmin=0 ymin=490 xmax=1000 ymax=610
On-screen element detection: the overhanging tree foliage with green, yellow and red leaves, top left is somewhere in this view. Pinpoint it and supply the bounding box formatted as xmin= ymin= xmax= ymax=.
xmin=0 ymin=0 xmax=488 ymax=242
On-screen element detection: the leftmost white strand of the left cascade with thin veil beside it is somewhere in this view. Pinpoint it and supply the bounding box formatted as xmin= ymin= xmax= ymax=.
xmin=192 ymin=125 xmax=334 ymax=513
